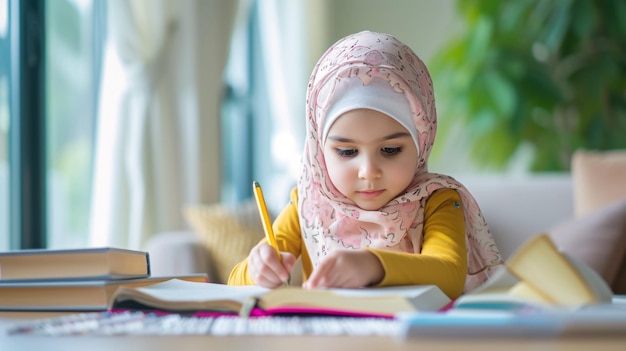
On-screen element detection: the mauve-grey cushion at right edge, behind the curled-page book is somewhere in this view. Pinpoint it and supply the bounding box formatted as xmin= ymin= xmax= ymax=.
xmin=549 ymin=199 xmax=626 ymax=294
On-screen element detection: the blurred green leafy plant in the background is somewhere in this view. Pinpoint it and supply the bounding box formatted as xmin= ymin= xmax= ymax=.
xmin=430 ymin=0 xmax=626 ymax=171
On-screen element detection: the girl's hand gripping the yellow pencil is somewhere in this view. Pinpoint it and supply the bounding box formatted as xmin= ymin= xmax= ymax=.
xmin=248 ymin=242 xmax=296 ymax=288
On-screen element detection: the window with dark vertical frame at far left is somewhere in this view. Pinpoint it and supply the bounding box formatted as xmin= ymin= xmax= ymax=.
xmin=0 ymin=0 xmax=106 ymax=250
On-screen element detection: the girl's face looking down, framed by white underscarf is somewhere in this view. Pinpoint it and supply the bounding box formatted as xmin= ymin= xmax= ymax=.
xmin=324 ymin=109 xmax=418 ymax=210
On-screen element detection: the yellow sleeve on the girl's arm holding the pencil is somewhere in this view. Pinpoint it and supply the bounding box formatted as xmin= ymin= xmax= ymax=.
xmin=228 ymin=188 xmax=304 ymax=285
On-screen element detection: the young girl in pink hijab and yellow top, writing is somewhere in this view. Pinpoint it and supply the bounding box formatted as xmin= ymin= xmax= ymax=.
xmin=228 ymin=31 xmax=502 ymax=298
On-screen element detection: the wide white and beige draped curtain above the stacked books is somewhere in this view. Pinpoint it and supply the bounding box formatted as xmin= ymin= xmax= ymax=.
xmin=90 ymin=0 xmax=238 ymax=249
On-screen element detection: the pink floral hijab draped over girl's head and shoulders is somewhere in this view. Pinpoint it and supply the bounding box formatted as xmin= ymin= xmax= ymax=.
xmin=298 ymin=31 xmax=502 ymax=291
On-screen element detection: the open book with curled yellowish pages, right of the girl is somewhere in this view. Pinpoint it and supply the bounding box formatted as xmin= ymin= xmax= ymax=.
xmin=453 ymin=234 xmax=613 ymax=309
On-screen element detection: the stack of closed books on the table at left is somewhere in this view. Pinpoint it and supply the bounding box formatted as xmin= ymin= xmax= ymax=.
xmin=0 ymin=247 xmax=208 ymax=312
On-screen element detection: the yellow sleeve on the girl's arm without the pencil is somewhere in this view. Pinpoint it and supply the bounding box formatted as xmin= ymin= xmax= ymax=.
xmin=367 ymin=189 xmax=467 ymax=299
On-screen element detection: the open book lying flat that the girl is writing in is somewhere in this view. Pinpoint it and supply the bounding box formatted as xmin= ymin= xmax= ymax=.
xmin=110 ymin=279 xmax=451 ymax=318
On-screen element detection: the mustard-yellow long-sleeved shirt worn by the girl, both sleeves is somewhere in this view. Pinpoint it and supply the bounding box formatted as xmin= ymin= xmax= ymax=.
xmin=228 ymin=189 xmax=467 ymax=299
